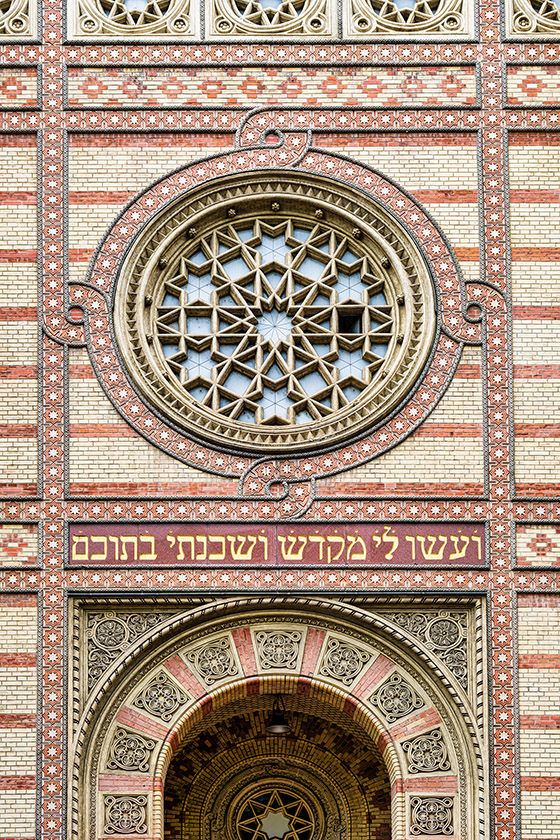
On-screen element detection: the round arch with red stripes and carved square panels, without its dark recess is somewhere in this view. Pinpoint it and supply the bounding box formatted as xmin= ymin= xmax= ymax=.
xmin=72 ymin=596 xmax=484 ymax=840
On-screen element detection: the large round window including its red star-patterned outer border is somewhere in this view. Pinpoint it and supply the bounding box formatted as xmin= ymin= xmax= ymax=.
xmin=70 ymin=125 xmax=480 ymax=475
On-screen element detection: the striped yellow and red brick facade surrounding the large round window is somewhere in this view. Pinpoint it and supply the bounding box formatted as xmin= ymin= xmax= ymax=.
xmin=0 ymin=0 xmax=560 ymax=840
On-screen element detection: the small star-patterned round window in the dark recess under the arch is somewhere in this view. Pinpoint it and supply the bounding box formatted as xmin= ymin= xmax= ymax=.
xmin=236 ymin=788 xmax=315 ymax=840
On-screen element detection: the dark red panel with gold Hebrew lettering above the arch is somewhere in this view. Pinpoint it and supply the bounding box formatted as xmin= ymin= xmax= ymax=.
xmin=68 ymin=522 xmax=485 ymax=566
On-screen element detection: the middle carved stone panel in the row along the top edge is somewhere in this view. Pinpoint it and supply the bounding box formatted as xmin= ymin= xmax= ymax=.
xmin=208 ymin=0 xmax=337 ymax=37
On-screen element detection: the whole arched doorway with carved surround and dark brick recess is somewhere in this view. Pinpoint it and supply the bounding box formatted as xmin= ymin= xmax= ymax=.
xmin=69 ymin=596 xmax=486 ymax=840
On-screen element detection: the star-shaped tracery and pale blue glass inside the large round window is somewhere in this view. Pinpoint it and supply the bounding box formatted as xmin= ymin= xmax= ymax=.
xmin=155 ymin=218 xmax=394 ymax=426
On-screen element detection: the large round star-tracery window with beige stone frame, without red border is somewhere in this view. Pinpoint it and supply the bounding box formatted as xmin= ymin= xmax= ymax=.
xmin=116 ymin=173 xmax=434 ymax=450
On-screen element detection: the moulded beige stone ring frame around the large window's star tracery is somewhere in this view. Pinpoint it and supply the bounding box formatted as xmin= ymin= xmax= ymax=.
xmin=115 ymin=170 xmax=436 ymax=455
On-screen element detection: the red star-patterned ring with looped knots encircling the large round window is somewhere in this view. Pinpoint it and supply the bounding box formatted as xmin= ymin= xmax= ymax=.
xmin=53 ymin=112 xmax=489 ymax=507
